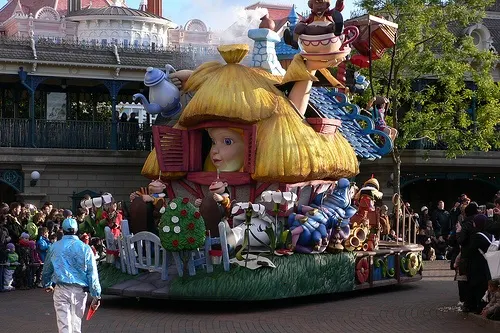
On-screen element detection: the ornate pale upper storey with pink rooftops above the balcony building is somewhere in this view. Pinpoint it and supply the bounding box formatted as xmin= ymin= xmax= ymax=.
xmin=0 ymin=0 xmax=219 ymax=50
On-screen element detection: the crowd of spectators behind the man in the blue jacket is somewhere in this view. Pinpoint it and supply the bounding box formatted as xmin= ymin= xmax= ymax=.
xmin=0 ymin=198 xmax=123 ymax=291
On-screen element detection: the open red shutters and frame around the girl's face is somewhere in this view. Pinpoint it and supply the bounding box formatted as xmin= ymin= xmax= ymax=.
xmin=153 ymin=121 xmax=257 ymax=185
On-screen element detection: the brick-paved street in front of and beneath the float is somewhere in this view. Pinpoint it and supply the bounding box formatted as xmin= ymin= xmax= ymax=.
xmin=0 ymin=262 xmax=500 ymax=333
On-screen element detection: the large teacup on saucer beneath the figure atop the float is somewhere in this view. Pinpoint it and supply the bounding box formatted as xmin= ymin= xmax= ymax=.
xmin=299 ymin=26 xmax=359 ymax=61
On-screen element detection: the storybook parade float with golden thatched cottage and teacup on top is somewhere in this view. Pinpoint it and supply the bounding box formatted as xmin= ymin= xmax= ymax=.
xmin=101 ymin=1 xmax=422 ymax=300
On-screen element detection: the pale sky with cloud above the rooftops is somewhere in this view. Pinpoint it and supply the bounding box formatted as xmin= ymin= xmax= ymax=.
xmin=0 ymin=0 xmax=354 ymax=30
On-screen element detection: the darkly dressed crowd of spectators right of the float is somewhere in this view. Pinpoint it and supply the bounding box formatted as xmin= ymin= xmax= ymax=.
xmin=410 ymin=191 xmax=500 ymax=320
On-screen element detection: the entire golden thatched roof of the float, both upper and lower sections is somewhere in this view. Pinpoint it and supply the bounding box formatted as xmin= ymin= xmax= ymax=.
xmin=172 ymin=44 xmax=359 ymax=183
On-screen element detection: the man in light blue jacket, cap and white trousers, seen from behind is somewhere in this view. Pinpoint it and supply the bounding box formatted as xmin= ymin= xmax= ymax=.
xmin=42 ymin=218 xmax=101 ymax=333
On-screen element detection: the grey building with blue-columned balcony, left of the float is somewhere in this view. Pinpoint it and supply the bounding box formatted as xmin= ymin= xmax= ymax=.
xmin=0 ymin=0 xmax=216 ymax=208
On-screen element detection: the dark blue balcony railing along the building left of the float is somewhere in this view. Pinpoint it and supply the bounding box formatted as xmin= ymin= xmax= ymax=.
xmin=0 ymin=118 xmax=152 ymax=151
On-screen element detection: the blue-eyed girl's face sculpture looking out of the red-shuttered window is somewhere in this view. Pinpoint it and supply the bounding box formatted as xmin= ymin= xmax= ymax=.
xmin=208 ymin=128 xmax=245 ymax=172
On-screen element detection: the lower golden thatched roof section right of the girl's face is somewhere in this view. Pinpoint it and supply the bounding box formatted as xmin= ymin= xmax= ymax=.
xmin=252 ymin=97 xmax=359 ymax=183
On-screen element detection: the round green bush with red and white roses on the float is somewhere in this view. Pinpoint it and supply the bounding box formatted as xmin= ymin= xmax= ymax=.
xmin=159 ymin=198 xmax=205 ymax=252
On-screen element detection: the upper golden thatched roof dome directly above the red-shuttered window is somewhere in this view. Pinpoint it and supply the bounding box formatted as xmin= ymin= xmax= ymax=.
xmin=179 ymin=44 xmax=280 ymax=127
